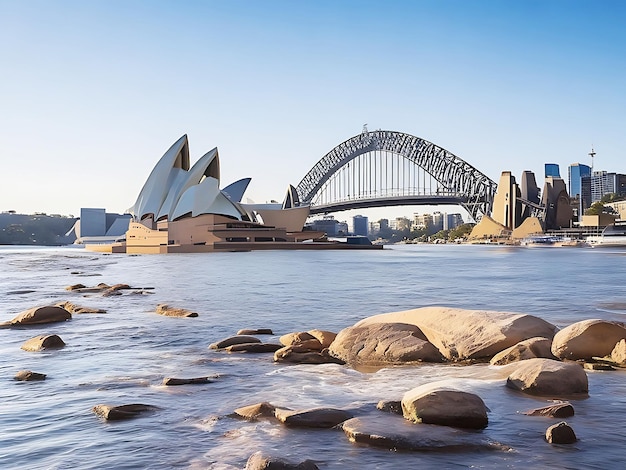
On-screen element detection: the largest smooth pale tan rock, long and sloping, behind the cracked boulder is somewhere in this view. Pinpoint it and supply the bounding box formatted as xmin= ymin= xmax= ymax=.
xmin=355 ymin=307 xmax=556 ymax=360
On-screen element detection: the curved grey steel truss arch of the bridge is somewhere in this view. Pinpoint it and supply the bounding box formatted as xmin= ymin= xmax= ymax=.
xmin=296 ymin=130 xmax=497 ymax=220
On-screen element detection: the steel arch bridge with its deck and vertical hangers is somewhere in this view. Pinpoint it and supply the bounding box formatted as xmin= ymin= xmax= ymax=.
xmin=296 ymin=129 xmax=497 ymax=220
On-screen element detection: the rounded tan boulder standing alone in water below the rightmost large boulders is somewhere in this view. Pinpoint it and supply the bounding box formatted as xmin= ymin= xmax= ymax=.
xmin=506 ymin=359 xmax=589 ymax=397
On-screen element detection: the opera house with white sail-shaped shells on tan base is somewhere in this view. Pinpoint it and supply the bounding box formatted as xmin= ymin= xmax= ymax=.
xmin=86 ymin=135 xmax=374 ymax=253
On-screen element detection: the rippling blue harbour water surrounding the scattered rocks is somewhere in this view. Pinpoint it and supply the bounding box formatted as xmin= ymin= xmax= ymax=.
xmin=0 ymin=245 xmax=626 ymax=469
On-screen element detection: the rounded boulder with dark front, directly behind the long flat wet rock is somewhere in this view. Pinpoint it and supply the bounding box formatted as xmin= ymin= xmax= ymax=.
xmin=402 ymin=383 xmax=488 ymax=429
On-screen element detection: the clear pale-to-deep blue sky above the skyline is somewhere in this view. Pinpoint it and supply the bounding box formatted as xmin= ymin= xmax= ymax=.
xmin=0 ymin=0 xmax=626 ymax=220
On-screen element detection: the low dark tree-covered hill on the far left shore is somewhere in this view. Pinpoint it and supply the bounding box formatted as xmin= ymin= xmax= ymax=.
xmin=0 ymin=212 xmax=77 ymax=246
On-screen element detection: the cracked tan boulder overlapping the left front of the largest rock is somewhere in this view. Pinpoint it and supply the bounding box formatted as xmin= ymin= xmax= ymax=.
xmin=329 ymin=323 xmax=443 ymax=366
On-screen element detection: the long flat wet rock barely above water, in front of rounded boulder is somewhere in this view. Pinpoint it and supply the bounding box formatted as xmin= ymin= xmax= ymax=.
xmin=341 ymin=414 xmax=511 ymax=452
